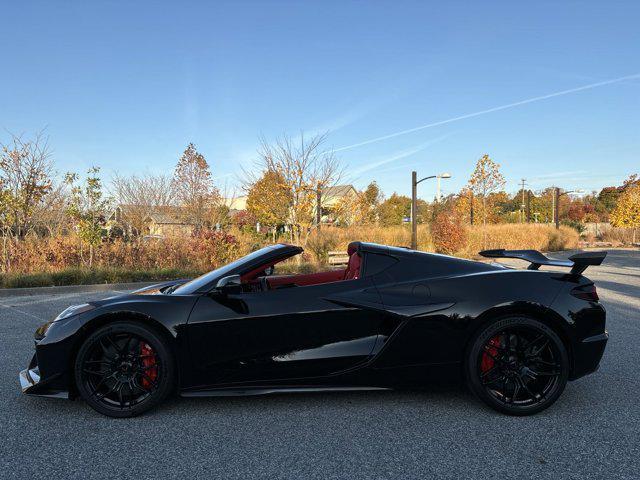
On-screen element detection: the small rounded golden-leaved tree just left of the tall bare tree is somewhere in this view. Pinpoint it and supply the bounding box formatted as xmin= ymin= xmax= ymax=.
xmin=247 ymin=170 xmax=291 ymax=241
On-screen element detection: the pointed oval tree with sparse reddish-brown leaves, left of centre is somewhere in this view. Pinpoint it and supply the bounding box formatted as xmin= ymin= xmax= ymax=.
xmin=171 ymin=143 xmax=221 ymax=229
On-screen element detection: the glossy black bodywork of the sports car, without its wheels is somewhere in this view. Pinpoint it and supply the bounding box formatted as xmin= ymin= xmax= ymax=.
xmin=20 ymin=242 xmax=607 ymax=413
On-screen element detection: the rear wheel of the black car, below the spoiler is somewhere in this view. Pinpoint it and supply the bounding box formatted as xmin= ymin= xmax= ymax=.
xmin=465 ymin=316 xmax=569 ymax=415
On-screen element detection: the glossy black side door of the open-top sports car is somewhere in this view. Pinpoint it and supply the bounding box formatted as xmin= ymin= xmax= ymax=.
xmin=187 ymin=278 xmax=385 ymax=385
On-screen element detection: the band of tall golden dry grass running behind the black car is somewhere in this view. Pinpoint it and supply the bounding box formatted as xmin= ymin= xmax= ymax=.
xmin=0 ymin=224 xmax=578 ymax=286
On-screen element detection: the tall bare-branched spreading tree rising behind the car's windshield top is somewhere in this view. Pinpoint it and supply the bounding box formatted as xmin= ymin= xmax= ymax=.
xmin=258 ymin=134 xmax=342 ymax=245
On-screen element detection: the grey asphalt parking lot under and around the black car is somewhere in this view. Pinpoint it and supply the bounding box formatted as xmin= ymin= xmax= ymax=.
xmin=0 ymin=250 xmax=640 ymax=479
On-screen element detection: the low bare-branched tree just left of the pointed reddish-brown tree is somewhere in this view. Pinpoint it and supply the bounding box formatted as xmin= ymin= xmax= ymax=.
xmin=112 ymin=173 xmax=175 ymax=235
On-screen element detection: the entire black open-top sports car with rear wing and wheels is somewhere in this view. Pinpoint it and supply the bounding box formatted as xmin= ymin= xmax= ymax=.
xmin=20 ymin=242 xmax=608 ymax=417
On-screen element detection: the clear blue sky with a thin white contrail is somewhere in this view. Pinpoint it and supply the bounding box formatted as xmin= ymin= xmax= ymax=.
xmin=0 ymin=0 xmax=640 ymax=199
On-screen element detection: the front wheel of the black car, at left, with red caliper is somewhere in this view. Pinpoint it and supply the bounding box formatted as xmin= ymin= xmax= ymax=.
xmin=74 ymin=321 xmax=176 ymax=418
